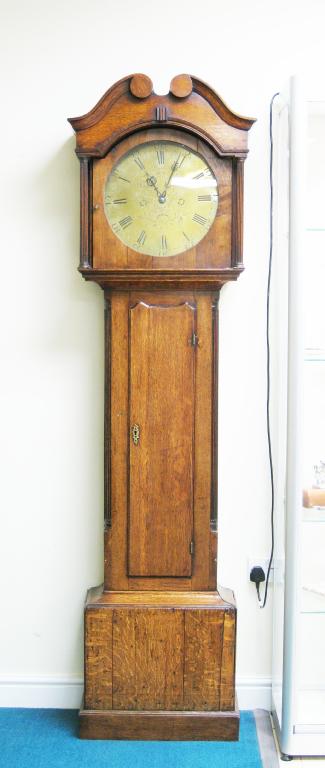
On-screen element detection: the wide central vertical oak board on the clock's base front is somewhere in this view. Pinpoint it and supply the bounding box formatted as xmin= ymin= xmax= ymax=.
xmin=113 ymin=609 xmax=184 ymax=710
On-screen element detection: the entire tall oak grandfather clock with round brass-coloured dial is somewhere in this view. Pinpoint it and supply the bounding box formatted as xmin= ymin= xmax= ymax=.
xmin=69 ymin=74 xmax=254 ymax=740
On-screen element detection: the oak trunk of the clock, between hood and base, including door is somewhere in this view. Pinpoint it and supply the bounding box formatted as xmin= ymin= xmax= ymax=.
xmin=105 ymin=291 xmax=217 ymax=590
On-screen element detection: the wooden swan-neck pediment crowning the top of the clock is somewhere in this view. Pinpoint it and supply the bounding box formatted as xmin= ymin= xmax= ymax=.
xmin=69 ymin=73 xmax=254 ymax=157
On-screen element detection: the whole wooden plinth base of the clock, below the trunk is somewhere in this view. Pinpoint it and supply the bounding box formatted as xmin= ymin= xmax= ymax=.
xmin=80 ymin=589 xmax=239 ymax=740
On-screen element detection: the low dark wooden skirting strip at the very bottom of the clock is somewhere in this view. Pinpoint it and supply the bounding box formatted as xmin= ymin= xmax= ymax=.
xmin=79 ymin=709 xmax=239 ymax=741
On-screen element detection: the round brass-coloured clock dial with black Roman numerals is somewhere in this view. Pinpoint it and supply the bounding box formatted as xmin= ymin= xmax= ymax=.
xmin=104 ymin=141 xmax=218 ymax=256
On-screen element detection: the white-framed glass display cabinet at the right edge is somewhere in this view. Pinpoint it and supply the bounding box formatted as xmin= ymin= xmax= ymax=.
xmin=272 ymin=77 xmax=325 ymax=759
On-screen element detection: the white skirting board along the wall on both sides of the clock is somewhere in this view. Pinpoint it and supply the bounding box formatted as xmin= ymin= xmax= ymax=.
xmin=0 ymin=675 xmax=271 ymax=710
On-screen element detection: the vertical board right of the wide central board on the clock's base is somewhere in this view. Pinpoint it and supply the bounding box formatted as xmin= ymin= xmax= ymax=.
xmin=184 ymin=610 xmax=224 ymax=710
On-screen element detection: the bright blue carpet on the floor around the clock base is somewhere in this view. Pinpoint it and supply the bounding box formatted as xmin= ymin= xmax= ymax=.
xmin=0 ymin=709 xmax=262 ymax=768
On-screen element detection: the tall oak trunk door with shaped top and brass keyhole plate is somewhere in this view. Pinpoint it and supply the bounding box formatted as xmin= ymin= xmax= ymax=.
xmin=128 ymin=302 xmax=196 ymax=577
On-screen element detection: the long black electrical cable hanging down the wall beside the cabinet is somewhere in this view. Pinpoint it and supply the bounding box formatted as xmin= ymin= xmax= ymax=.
xmin=260 ymin=93 xmax=279 ymax=608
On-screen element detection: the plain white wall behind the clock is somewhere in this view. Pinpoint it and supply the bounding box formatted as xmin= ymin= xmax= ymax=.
xmin=0 ymin=0 xmax=325 ymax=706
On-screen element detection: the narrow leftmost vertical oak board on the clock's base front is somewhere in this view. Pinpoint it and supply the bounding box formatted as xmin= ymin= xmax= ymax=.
xmin=85 ymin=608 xmax=112 ymax=709
